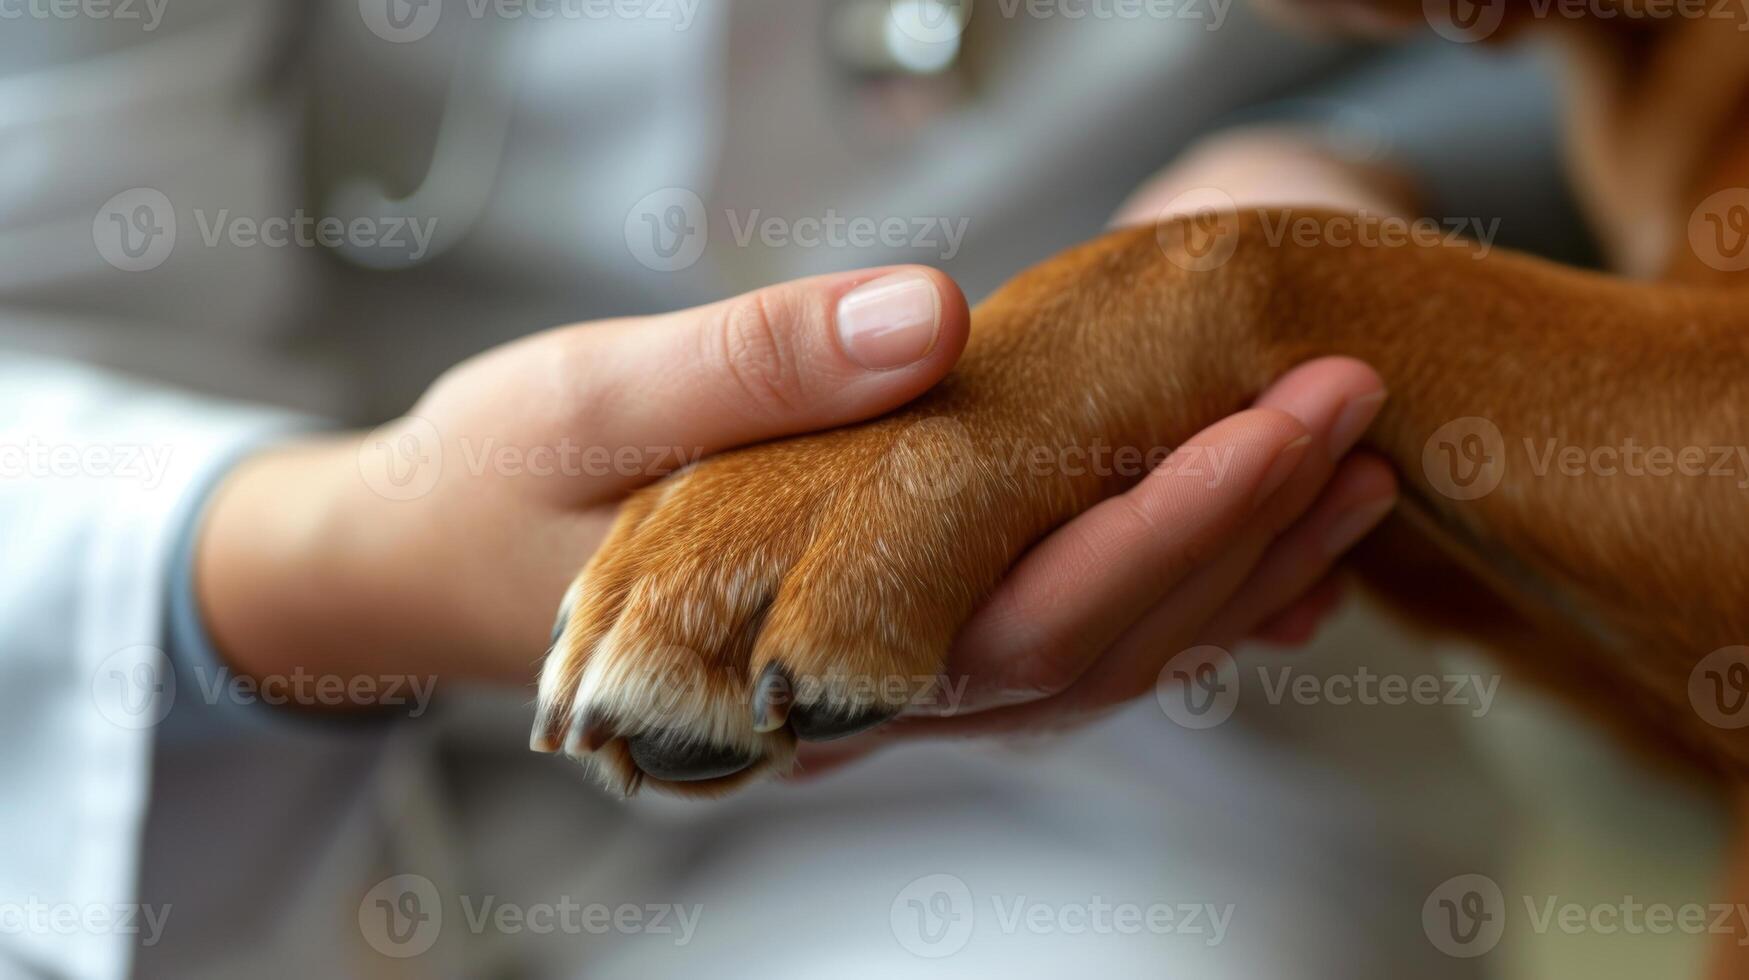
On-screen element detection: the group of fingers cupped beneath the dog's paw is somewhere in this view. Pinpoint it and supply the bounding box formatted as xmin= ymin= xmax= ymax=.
xmin=801 ymin=357 xmax=1396 ymax=774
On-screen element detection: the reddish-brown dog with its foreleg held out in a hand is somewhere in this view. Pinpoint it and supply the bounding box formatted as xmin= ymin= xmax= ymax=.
xmin=533 ymin=0 xmax=1749 ymax=959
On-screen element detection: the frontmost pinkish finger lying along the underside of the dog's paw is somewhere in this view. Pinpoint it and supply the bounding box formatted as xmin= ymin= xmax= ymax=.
xmin=948 ymin=402 xmax=1312 ymax=714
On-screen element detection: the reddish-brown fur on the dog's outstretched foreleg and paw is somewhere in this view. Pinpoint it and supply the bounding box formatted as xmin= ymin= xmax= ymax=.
xmin=528 ymin=210 xmax=1749 ymax=789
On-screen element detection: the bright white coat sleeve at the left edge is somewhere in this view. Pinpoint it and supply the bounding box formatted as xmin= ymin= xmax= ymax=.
xmin=0 ymin=354 xmax=308 ymax=980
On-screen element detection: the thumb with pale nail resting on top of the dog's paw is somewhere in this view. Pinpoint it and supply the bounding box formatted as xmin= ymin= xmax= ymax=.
xmin=531 ymin=266 xmax=971 ymax=483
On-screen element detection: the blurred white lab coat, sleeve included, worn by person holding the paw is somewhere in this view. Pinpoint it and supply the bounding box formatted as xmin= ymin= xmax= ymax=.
xmin=0 ymin=0 xmax=1602 ymax=980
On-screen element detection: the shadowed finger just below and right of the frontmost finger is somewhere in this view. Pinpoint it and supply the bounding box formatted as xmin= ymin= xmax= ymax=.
xmin=1203 ymin=455 xmax=1397 ymax=646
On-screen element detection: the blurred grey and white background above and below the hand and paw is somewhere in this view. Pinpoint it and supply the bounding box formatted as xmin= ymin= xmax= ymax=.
xmin=0 ymin=0 xmax=1723 ymax=980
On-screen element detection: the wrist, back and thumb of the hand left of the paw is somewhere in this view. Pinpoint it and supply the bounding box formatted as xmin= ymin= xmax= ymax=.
xmin=196 ymin=268 xmax=969 ymax=684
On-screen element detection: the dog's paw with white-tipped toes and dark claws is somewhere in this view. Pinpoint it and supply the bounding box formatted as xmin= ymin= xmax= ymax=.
xmin=532 ymin=415 xmax=1027 ymax=795
